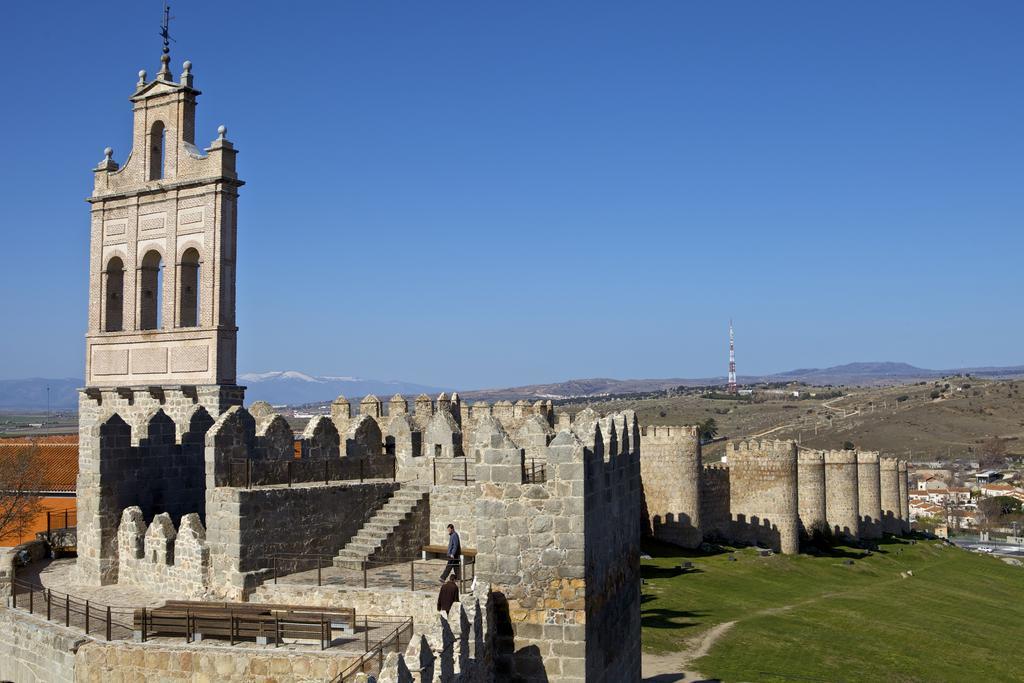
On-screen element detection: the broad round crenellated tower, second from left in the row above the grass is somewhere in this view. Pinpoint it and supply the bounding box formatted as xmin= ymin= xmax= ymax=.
xmin=728 ymin=441 xmax=800 ymax=553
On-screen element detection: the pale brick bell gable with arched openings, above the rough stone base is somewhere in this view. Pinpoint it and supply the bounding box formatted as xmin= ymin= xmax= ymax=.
xmin=85 ymin=54 xmax=243 ymax=387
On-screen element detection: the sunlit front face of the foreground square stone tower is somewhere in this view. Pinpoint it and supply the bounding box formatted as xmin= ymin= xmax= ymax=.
xmin=475 ymin=418 xmax=589 ymax=683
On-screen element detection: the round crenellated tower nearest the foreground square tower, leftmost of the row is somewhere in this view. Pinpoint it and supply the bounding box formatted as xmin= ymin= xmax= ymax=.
xmin=640 ymin=426 xmax=702 ymax=548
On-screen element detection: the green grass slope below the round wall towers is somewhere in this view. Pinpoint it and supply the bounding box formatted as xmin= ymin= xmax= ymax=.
xmin=642 ymin=540 xmax=1024 ymax=682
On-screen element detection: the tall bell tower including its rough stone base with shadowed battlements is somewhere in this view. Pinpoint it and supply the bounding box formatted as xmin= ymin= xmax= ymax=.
xmin=78 ymin=50 xmax=244 ymax=584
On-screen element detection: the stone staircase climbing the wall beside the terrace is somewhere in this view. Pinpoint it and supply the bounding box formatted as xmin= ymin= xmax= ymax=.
xmin=334 ymin=483 xmax=430 ymax=569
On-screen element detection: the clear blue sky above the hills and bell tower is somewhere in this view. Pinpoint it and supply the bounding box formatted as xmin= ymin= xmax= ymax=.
xmin=0 ymin=0 xmax=1024 ymax=388
